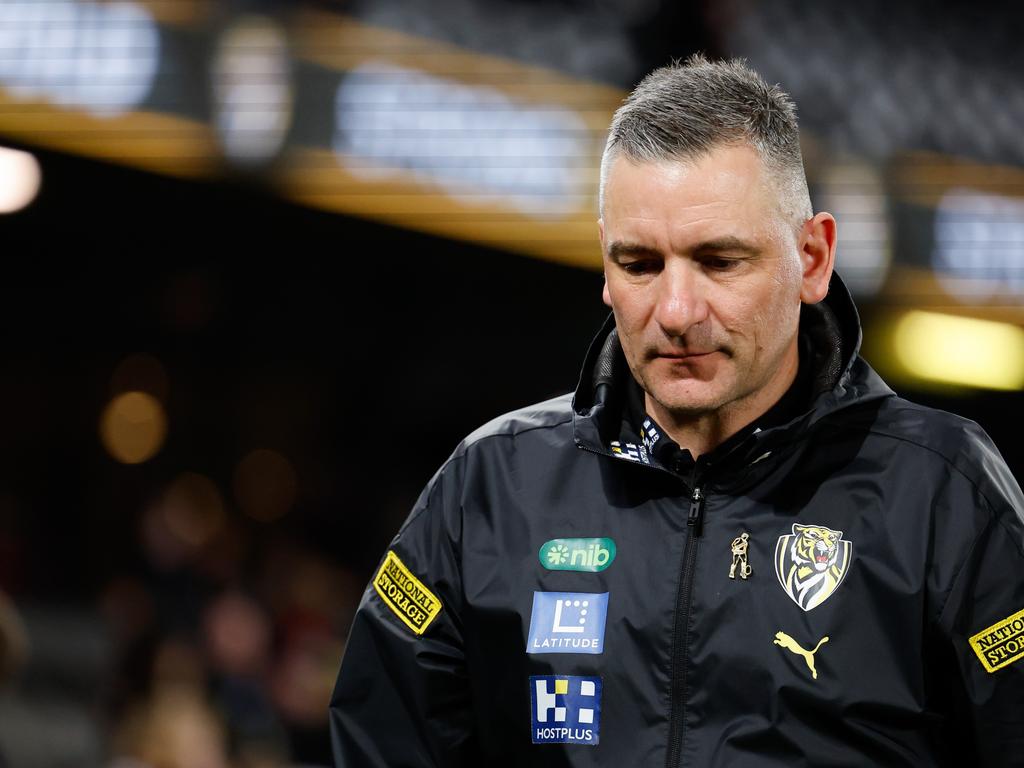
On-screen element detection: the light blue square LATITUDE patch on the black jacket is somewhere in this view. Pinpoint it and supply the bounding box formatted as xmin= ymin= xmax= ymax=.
xmin=526 ymin=592 xmax=608 ymax=653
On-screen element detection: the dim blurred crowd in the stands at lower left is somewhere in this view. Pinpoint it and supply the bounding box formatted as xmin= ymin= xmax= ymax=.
xmin=0 ymin=479 xmax=364 ymax=768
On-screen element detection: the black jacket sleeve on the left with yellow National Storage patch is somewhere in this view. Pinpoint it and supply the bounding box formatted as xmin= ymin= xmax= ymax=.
xmin=330 ymin=459 xmax=476 ymax=768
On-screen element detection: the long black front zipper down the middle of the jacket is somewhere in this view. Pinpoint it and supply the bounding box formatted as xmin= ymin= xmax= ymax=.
xmin=666 ymin=479 xmax=705 ymax=768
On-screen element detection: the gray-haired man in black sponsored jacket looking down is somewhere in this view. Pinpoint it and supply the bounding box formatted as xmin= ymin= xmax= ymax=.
xmin=331 ymin=57 xmax=1024 ymax=768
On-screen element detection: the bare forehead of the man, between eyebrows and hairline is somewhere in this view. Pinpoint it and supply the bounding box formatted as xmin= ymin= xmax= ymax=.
xmin=602 ymin=144 xmax=781 ymax=248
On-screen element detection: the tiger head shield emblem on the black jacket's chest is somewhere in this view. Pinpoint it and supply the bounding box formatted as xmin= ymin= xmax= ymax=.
xmin=775 ymin=523 xmax=853 ymax=610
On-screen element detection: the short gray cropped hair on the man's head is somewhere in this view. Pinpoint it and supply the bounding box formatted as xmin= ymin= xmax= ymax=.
xmin=598 ymin=53 xmax=813 ymax=225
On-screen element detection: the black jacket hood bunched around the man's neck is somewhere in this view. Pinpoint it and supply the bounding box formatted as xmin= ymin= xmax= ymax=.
xmin=572 ymin=271 xmax=894 ymax=468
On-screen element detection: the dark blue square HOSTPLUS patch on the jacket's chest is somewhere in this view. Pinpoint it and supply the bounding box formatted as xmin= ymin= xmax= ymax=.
xmin=529 ymin=675 xmax=601 ymax=744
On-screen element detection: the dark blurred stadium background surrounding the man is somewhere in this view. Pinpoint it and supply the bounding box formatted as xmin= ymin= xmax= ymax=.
xmin=0 ymin=0 xmax=1024 ymax=768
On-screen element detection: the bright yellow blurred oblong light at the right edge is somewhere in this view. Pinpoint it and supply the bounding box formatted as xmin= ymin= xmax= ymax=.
xmin=893 ymin=310 xmax=1024 ymax=390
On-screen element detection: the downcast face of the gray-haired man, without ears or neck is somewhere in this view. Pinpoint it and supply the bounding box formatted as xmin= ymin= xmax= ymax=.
xmin=599 ymin=145 xmax=803 ymax=419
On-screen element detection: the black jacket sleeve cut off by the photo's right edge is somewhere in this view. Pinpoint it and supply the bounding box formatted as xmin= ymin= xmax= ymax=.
xmin=939 ymin=436 xmax=1024 ymax=767
